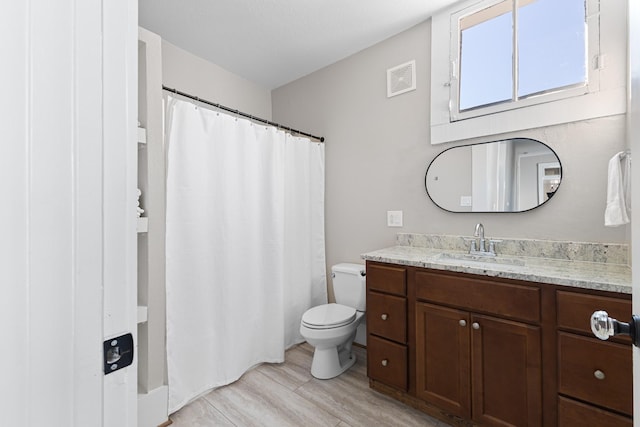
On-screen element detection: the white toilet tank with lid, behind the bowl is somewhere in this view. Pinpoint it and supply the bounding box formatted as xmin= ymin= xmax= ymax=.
xmin=331 ymin=263 xmax=367 ymax=311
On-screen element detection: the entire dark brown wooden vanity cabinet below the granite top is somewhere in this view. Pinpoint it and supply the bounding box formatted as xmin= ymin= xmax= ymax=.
xmin=367 ymin=261 xmax=633 ymax=427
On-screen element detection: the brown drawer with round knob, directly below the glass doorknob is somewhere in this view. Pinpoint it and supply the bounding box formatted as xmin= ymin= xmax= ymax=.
xmin=558 ymin=332 xmax=633 ymax=415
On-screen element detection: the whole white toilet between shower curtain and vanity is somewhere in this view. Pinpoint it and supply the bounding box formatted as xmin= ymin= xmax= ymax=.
xmin=300 ymin=263 xmax=366 ymax=380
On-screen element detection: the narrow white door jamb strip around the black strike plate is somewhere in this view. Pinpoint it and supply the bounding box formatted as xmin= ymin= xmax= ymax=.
xmin=102 ymin=0 xmax=139 ymax=427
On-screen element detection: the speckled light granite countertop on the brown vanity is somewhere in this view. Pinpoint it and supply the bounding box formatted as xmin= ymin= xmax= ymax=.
xmin=362 ymin=235 xmax=631 ymax=294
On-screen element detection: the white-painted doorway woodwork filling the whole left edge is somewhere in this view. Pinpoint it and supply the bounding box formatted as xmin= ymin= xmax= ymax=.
xmin=0 ymin=0 xmax=137 ymax=427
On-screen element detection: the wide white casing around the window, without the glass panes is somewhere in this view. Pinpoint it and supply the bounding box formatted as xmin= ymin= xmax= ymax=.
xmin=431 ymin=0 xmax=627 ymax=144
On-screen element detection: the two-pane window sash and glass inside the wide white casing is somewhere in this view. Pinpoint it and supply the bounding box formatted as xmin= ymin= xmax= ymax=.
xmin=452 ymin=0 xmax=588 ymax=120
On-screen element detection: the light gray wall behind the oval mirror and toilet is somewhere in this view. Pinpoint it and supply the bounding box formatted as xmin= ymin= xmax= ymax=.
xmin=272 ymin=21 xmax=630 ymax=278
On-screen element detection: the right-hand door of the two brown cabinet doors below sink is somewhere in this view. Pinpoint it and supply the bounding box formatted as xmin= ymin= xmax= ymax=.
xmin=470 ymin=315 xmax=542 ymax=426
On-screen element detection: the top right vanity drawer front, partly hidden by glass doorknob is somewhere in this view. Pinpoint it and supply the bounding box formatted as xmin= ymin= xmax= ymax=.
xmin=556 ymin=291 xmax=631 ymax=343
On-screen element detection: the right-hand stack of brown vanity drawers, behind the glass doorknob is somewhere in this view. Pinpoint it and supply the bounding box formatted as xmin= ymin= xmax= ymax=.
xmin=556 ymin=290 xmax=633 ymax=427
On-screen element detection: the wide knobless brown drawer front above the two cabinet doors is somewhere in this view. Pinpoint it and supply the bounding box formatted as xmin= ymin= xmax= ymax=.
xmin=415 ymin=271 xmax=540 ymax=323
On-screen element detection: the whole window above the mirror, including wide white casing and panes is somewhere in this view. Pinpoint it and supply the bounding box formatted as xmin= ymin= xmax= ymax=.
xmin=430 ymin=0 xmax=627 ymax=144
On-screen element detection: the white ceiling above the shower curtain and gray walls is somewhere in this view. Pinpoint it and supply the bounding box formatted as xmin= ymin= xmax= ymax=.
xmin=139 ymin=0 xmax=458 ymax=89
